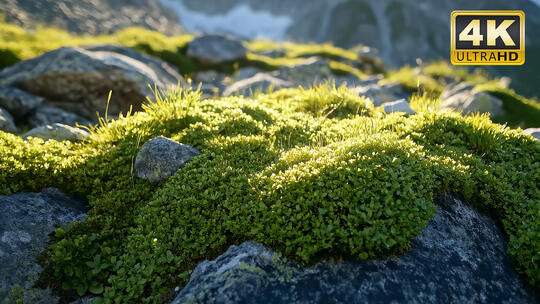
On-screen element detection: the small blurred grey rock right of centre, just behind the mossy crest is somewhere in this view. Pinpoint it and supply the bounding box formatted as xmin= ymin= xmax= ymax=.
xmin=352 ymin=77 xmax=410 ymax=107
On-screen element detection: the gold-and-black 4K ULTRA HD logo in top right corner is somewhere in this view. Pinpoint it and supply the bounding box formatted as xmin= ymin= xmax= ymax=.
xmin=450 ymin=11 xmax=525 ymax=65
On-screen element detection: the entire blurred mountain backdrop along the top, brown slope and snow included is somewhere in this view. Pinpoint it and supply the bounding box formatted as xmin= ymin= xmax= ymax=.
xmin=0 ymin=0 xmax=540 ymax=97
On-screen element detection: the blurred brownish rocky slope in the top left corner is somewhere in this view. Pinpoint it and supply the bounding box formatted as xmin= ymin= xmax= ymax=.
xmin=0 ymin=0 xmax=182 ymax=35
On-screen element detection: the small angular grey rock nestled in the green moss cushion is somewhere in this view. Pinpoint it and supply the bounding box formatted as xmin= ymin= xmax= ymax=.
xmin=135 ymin=136 xmax=201 ymax=182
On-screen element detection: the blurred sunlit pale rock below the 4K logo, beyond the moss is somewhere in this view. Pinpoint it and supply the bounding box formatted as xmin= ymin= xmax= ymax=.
xmin=441 ymin=82 xmax=504 ymax=117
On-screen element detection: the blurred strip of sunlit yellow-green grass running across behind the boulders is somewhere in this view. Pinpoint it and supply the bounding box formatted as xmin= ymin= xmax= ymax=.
xmin=0 ymin=21 xmax=540 ymax=128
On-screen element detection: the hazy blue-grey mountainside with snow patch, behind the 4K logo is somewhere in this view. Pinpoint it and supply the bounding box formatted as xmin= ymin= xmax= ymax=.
xmin=159 ymin=0 xmax=540 ymax=96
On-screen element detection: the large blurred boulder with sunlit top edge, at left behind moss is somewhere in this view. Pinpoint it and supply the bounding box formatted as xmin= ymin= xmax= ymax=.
xmin=0 ymin=46 xmax=183 ymax=119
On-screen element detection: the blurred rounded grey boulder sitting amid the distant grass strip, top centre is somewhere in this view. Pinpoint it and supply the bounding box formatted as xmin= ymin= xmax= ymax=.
xmin=187 ymin=35 xmax=247 ymax=65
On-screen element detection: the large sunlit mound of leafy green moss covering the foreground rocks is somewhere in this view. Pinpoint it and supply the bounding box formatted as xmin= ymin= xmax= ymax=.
xmin=0 ymin=82 xmax=540 ymax=303
